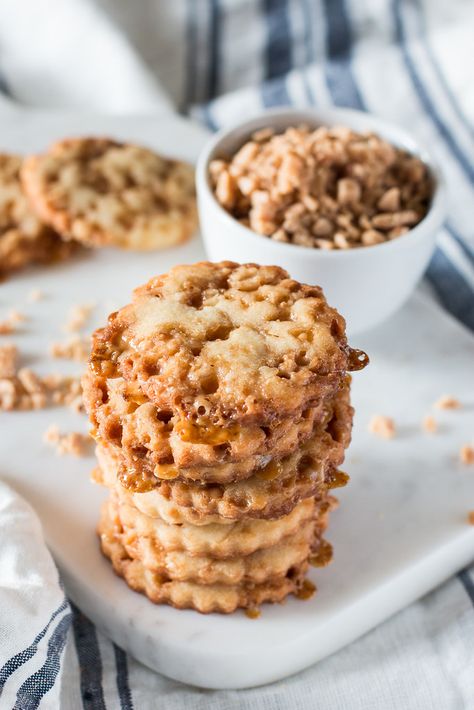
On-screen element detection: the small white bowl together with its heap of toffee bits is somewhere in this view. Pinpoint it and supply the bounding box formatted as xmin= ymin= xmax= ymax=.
xmin=197 ymin=109 xmax=446 ymax=333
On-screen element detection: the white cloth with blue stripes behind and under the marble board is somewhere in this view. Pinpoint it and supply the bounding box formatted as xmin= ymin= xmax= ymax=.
xmin=0 ymin=0 xmax=474 ymax=710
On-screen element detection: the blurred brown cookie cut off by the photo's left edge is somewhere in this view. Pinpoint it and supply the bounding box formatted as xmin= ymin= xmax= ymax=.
xmin=0 ymin=153 xmax=77 ymax=278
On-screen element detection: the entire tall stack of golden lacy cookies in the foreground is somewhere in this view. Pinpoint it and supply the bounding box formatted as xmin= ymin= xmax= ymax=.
xmin=83 ymin=262 xmax=367 ymax=614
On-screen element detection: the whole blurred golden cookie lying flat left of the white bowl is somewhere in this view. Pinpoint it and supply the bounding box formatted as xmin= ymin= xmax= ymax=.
xmin=21 ymin=138 xmax=197 ymax=250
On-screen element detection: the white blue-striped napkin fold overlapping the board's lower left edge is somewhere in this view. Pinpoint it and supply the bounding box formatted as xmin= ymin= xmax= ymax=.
xmin=0 ymin=482 xmax=71 ymax=710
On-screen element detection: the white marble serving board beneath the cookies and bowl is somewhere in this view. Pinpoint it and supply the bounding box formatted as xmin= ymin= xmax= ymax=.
xmin=0 ymin=115 xmax=474 ymax=688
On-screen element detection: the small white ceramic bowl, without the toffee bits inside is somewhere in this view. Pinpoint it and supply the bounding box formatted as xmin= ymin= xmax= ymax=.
xmin=196 ymin=109 xmax=446 ymax=333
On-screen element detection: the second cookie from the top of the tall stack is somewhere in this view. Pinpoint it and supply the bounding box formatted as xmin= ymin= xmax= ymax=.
xmin=83 ymin=377 xmax=352 ymax=491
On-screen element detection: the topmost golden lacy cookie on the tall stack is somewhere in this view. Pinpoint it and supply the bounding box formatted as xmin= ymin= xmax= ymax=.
xmin=88 ymin=262 xmax=367 ymax=426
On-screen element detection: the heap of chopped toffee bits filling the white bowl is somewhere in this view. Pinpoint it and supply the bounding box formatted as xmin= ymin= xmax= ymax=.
xmin=209 ymin=126 xmax=433 ymax=250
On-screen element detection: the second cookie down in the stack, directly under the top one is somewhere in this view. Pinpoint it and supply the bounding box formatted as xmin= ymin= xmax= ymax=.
xmin=82 ymin=371 xmax=333 ymax=490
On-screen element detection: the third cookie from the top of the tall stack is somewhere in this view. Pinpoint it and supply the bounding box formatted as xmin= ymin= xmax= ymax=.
xmin=95 ymin=384 xmax=352 ymax=525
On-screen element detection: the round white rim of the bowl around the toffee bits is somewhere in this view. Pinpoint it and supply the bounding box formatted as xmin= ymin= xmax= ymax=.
xmin=196 ymin=106 xmax=447 ymax=259
